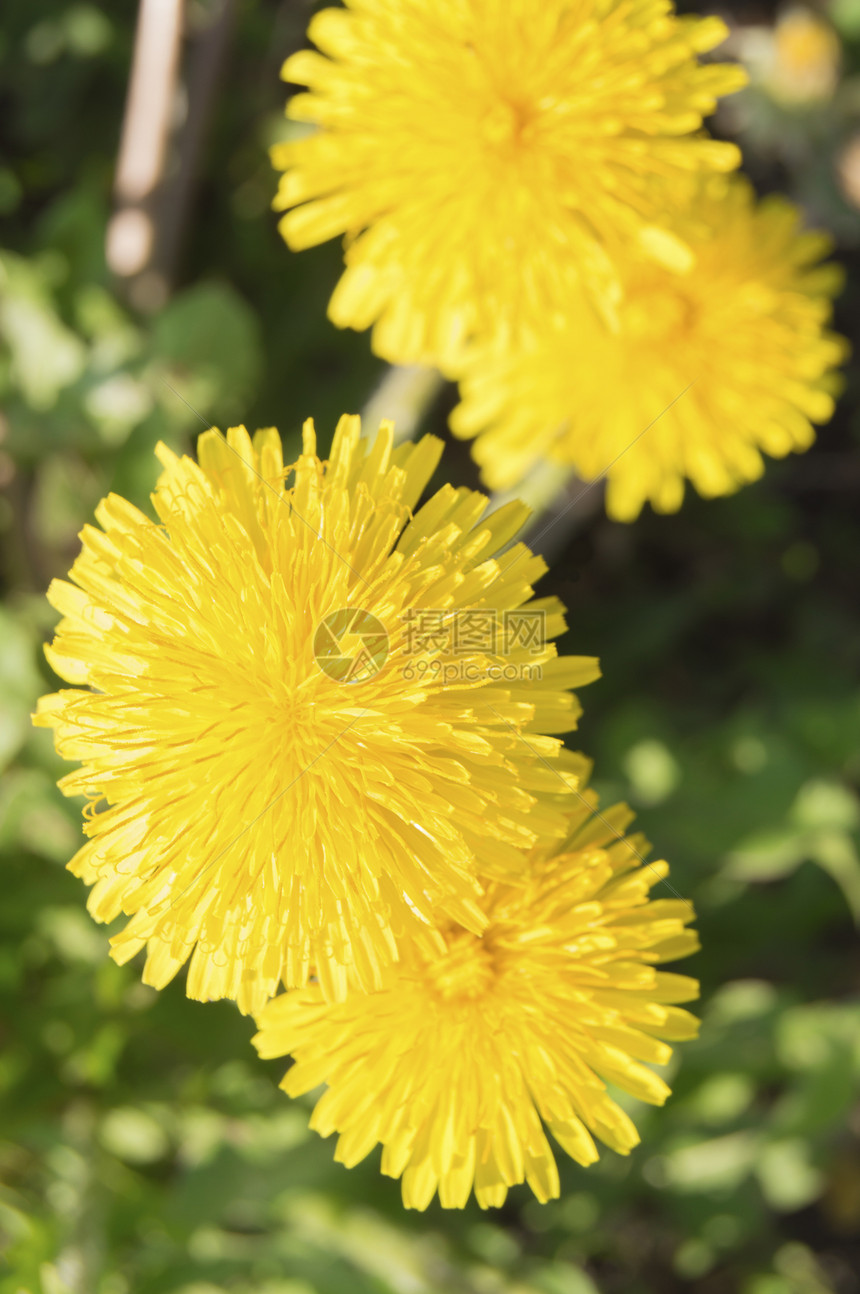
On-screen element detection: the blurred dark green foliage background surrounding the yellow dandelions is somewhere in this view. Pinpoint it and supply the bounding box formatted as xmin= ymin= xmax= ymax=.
xmin=0 ymin=0 xmax=860 ymax=1294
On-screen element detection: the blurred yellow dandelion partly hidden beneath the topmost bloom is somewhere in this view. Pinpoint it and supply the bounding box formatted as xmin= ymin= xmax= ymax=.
xmin=451 ymin=177 xmax=846 ymax=520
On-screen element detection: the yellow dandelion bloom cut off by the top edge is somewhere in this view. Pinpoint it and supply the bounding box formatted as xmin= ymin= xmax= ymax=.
xmin=273 ymin=0 xmax=745 ymax=366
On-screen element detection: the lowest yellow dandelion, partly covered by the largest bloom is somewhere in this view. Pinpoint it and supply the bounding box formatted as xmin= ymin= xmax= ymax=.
xmin=253 ymin=792 xmax=698 ymax=1209
